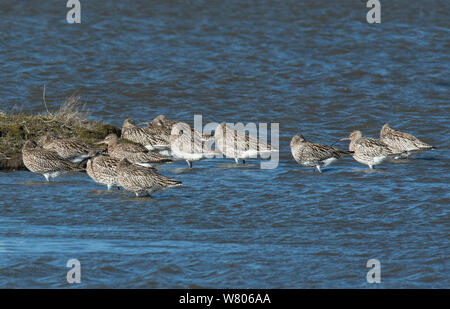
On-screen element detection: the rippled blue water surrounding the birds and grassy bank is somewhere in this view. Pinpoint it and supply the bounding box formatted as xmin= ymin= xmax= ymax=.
xmin=0 ymin=1 xmax=450 ymax=288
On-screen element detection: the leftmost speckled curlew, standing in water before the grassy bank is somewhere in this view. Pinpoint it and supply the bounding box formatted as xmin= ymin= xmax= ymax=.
xmin=22 ymin=141 xmax=83 ymax=181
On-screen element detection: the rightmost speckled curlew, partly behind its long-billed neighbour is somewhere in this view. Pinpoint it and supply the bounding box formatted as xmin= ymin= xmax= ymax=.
xmin=380 ymin=123 xmax=434 ymax=156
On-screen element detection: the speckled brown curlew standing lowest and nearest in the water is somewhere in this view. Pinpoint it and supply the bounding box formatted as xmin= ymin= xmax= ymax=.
xmin=117 ymin=159 xmax=181 ymax=196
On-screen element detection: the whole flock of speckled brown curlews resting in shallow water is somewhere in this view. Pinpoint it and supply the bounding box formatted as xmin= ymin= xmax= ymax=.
xmin=22 ymin=115 xmax=434 ymax=196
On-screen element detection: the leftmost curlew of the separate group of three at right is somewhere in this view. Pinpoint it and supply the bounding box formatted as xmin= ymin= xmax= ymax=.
xmin=291 ymin=134 xmax=351 ymax=172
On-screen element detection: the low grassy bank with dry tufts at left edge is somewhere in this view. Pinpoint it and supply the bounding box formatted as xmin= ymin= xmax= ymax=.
xmin=0 ymin=97 xmax=120 ymax=170
